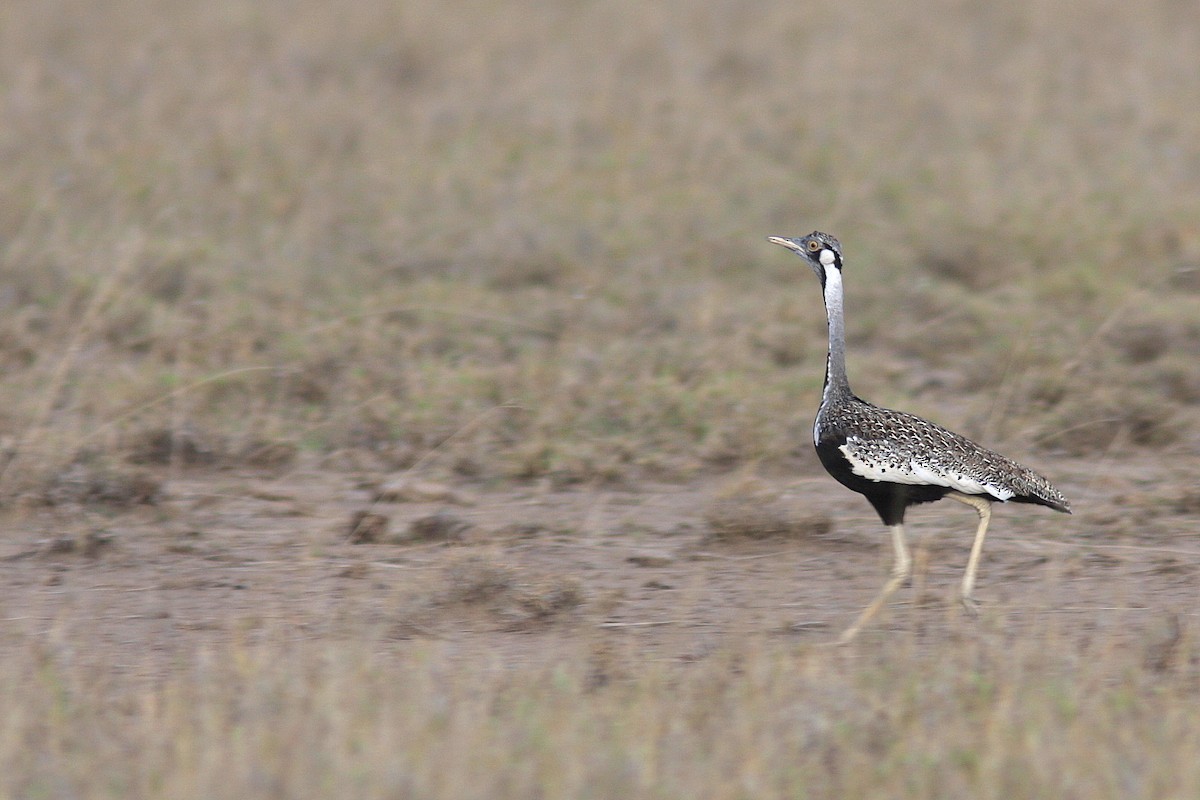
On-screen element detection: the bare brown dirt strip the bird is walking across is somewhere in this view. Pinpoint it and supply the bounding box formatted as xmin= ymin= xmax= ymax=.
xmin=0 ymin=448 xmax=1200 ymax=679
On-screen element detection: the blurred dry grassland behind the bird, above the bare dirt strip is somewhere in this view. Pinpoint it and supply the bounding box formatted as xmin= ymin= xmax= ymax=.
xmin=0 ymin=0 xmax=1200 ymax=493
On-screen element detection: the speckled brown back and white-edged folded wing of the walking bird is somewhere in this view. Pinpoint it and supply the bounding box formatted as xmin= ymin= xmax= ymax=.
xmin=814 ymin=395 xmax=1070 ymax=513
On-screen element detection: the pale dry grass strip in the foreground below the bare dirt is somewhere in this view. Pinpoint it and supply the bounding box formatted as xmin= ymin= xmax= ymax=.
xmin=0 ymin=626 xmax=1200 ymax=800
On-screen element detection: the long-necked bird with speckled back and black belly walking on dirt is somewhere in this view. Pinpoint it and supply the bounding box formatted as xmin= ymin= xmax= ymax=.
xmin=767 ymin=230 xmax=1070 ymax=644
